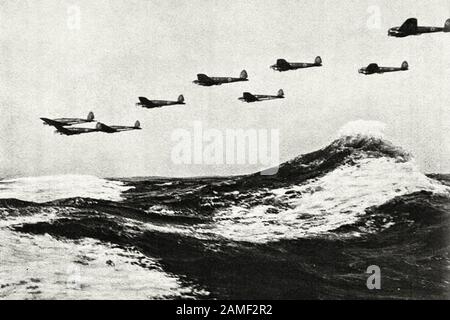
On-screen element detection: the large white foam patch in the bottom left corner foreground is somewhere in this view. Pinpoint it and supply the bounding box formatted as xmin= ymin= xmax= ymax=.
xmin=0 ymin=228 xmax=207 ymax=299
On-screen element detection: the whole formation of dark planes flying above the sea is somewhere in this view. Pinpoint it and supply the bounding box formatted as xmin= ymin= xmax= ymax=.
xmin=41 ymin=18 xmax=450 ymax=136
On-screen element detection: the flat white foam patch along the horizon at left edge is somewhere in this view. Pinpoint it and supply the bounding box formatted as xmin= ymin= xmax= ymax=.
xmin=0 ymin=175 xmax=132 ymax=203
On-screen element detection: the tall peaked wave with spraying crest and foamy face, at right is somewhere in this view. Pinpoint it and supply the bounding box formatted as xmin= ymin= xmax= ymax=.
xmin=199 ymin=120 xmax=450 ymax=242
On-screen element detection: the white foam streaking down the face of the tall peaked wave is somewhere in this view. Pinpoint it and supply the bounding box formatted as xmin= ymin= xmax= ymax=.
xmin=208 ymin=158 xmax=450 ymax=242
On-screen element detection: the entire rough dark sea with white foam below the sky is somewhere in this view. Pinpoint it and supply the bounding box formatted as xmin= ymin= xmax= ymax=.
xmin=0 ymin=121 xmax=450 ymax=299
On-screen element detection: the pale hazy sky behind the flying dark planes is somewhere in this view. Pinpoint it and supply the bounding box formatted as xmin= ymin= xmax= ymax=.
xmin=0 ymin=0 xmax=450 ymax=177
